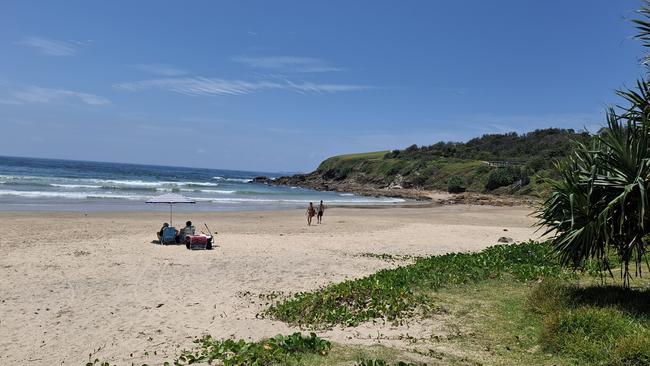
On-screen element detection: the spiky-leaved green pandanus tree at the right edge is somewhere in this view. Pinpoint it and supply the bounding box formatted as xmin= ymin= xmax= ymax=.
xmin=536 ymin=1 xmax=650 ymax=286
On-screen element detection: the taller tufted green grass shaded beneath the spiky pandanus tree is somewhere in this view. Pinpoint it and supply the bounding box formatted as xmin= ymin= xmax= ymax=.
xmin=528 ymin=281 xmax=650 ymax=365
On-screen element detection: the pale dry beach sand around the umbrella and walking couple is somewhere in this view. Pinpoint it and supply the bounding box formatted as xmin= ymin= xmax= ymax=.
xmin=0 ymin=205 xmax=536 ymax=365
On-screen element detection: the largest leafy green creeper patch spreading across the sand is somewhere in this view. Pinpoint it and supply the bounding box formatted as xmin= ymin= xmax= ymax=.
xmin=268 ymin=242 xmax=562 ymax=328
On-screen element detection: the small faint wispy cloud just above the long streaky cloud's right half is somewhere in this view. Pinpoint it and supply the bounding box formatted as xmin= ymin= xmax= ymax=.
xmin=233 ymin=56 xmax=343 ymax=73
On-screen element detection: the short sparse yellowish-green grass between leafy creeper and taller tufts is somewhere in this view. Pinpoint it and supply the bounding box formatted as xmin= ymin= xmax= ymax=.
xmin=426 ymin=278 xmax=575 ymax=366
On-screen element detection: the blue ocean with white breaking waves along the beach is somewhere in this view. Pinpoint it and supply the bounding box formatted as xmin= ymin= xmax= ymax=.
xmin=0 ymin=156 xmax=403 ymax=212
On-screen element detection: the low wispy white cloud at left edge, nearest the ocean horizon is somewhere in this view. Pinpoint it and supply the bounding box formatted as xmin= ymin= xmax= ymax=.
xmin=4 ymin=86 xmax=110 ymax=106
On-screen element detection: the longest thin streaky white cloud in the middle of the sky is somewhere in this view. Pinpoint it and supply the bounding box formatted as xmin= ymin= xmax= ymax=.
xmin=114 ymin=77 xmax=372 ymax=96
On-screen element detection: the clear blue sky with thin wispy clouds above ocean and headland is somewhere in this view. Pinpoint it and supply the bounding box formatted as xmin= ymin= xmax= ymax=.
xmin=0 ymin=0 xmax=644 ymax=172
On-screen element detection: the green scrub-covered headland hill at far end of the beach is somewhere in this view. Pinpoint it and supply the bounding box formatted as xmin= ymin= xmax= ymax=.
xmin=306 ymin=128 xmax=591 ymax=195
